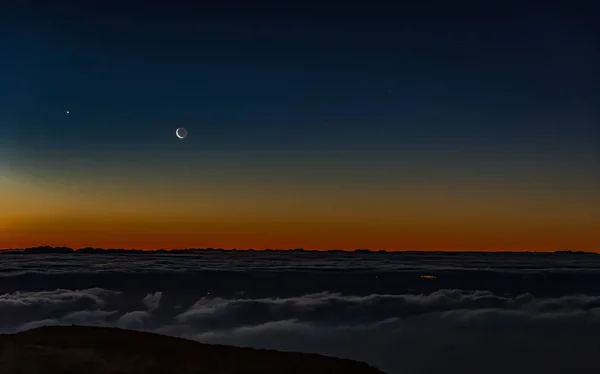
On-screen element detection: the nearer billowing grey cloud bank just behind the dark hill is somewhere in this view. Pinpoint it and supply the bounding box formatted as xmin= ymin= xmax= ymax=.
xmin=0 ymin=288 xmax=600 ymax=374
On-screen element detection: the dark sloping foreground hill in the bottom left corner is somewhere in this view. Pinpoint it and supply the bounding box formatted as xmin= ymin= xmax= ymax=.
xmin=0 ymin=326 xmax=383 ymax=374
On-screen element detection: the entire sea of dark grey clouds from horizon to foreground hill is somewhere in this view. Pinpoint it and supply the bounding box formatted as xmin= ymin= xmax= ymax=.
xmin=0 ymin=252 xmax=600 ymax=374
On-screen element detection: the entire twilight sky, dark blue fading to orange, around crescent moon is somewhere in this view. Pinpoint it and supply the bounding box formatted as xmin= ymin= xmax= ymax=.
xmin=0 ymin=0 xmax=600 ymax=250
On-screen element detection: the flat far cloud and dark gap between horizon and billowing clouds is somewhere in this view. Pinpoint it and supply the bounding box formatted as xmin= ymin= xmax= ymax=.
xmin=0 ymin=252 xmax=600 ymax=302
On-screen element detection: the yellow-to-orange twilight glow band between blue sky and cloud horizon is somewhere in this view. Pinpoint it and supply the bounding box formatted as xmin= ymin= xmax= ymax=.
xmin=0 ymin=158 xmax=600 ymax=252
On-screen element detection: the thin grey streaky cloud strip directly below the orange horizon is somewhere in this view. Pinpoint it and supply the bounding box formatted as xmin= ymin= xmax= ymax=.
xmin=0 ymin=251 xmax=600 ymax=278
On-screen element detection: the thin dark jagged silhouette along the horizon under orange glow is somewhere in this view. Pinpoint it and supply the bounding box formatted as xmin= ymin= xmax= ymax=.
xmin=0 ymin=246 xmax=599 ymax=256
